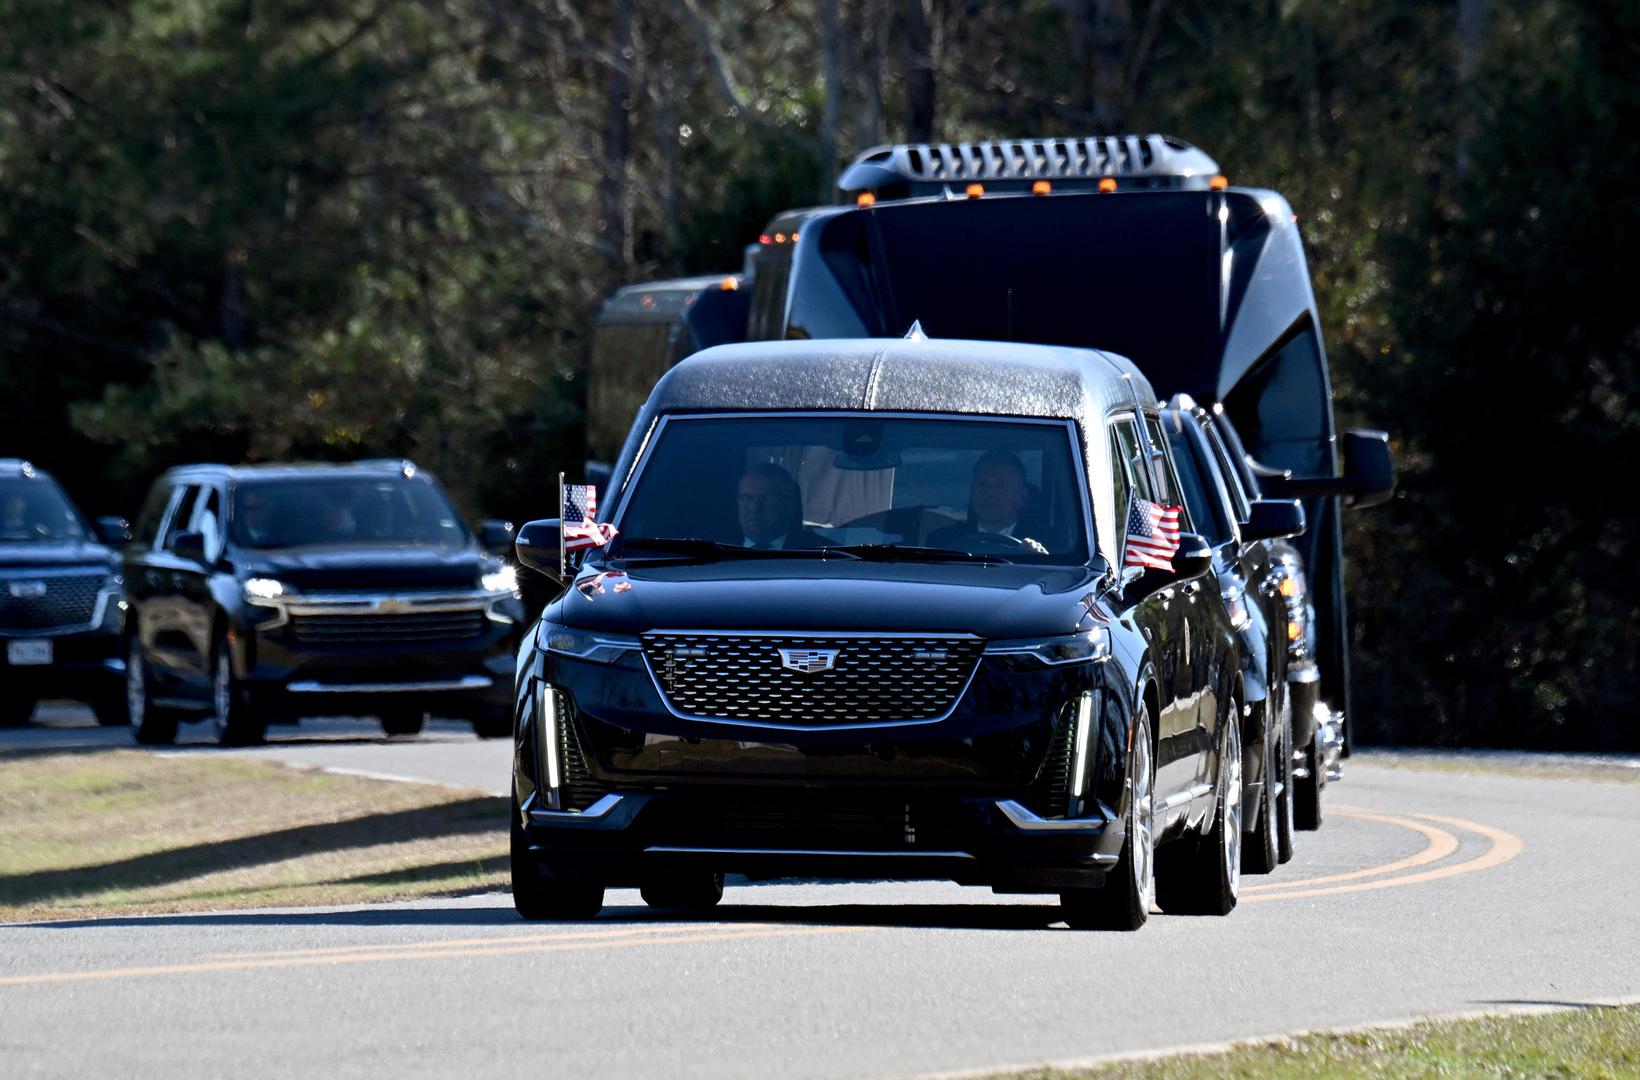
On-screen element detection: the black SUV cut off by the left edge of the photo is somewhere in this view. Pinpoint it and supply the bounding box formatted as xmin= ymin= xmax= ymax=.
xmin=0 ymin=457 xmax=125 ymax=726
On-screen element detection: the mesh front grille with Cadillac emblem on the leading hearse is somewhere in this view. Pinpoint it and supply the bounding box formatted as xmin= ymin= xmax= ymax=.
xmin=643 ymin=633 xmax=984 ymax=728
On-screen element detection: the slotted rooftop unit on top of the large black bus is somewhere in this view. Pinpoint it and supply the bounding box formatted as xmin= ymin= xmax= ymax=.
xmin=836 ymin=134 xmax=1219 ymax=198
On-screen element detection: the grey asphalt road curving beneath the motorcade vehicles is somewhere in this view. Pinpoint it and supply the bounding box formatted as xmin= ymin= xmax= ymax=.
xmin=0 ymin=704 xmax=1640 ymax=1078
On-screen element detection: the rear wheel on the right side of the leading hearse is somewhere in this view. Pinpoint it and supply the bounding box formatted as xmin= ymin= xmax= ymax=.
xmin=1156 ymin=698 xmax=1241 ymax=914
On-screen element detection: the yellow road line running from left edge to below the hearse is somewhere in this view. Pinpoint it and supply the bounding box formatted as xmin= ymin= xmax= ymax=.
xmin=0 ymin=926 xmax=876 ymax=987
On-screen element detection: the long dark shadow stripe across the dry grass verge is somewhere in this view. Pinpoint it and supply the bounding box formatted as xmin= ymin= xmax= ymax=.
xmin=0 ymin=796 xmax=507 ymax=921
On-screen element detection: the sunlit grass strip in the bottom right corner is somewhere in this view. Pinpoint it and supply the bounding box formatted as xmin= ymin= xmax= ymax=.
xmin=997 ymin=1006 xmax=1640 ymax=1080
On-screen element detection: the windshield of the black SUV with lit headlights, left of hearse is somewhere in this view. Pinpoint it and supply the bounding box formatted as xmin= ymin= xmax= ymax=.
xmin=231 ymin=477 xmax=467 ymax=547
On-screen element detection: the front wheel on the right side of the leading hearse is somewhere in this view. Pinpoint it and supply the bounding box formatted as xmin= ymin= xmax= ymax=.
xmin=1059 ymin=698 xmax=1156 ymax=931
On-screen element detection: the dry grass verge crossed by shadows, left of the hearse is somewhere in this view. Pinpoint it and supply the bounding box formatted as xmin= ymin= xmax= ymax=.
xmin=0 ymin=751 xmax=507 ymax=923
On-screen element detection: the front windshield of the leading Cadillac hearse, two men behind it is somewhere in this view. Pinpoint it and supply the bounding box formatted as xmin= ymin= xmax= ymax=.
xmin=617 ymin=413 xmax=1089 ymax=564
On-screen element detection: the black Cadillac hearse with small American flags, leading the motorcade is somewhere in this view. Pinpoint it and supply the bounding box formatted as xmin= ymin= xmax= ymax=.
xmin=512 ymin=339 xmax=1245 ymax=928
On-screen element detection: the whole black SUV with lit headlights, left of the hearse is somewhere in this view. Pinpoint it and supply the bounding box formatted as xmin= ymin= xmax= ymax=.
xmin=125 ymin=461 xmax=523 ymax=744
